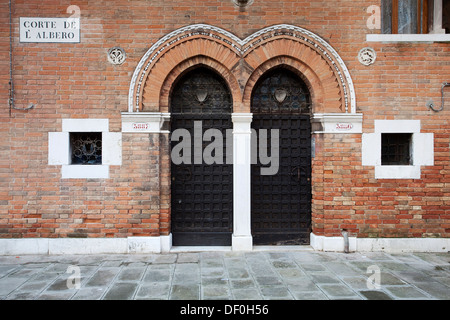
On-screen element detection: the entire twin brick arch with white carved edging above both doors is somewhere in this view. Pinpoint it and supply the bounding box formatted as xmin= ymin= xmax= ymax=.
xmin=128 ymin=24 xmax=356 ymax=113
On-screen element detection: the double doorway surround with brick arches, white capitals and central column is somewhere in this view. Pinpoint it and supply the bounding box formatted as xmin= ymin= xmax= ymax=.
xmin=122 ymin=24 xmax=362 ymax=250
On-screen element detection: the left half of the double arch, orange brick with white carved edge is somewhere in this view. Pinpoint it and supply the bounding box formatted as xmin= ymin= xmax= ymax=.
xmin=128 ymin=25 xmax=240 ymax=112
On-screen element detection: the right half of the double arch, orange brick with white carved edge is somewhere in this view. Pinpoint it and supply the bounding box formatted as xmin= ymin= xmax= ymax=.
xmin=242 ymin=25 xmax=356 ymax=113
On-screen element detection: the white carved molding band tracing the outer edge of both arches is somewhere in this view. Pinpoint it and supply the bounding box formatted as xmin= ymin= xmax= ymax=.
xmin=128 ymin=24 xmax=356 ymax=113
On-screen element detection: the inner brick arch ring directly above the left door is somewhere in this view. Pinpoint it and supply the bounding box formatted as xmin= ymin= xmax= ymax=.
xmin=158 ymin=55 xmax=241 ymax=112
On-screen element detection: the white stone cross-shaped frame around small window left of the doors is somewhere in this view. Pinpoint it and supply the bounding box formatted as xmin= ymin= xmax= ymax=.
xmin=48 ymin=119 xmax=122 ymax=179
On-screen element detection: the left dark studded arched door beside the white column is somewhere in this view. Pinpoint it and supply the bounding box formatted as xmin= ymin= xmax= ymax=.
xmin=170 ymin=67 xmax=233 ymax=246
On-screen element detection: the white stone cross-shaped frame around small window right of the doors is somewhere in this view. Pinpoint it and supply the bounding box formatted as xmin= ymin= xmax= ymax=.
xmin=362 ymin=120 xmax=434 ymax=179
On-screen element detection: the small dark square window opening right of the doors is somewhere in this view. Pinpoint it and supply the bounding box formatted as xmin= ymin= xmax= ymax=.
xmin=381 ymin=133 xmax=412 ymax=166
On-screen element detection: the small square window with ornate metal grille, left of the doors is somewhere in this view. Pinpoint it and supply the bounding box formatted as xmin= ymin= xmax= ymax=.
xmin=70 ymin=132 xmax=102 ymax=165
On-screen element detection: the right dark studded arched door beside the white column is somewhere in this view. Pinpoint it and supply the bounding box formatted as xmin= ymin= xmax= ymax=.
xmin=251 ymin=67 xmax=311 ymax=245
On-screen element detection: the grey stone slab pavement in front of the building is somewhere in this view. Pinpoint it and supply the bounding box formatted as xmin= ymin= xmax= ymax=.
xmin=0 ymin=248 xmax=450 ymax=300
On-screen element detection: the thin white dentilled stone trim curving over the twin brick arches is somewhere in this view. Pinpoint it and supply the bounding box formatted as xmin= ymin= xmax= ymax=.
xmin=128 ymin=24 xmax=356 ymax=113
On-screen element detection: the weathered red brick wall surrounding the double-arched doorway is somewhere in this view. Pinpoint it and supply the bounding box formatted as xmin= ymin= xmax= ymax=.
xmin=0 ymin=0 xmax=450 ymax=238
